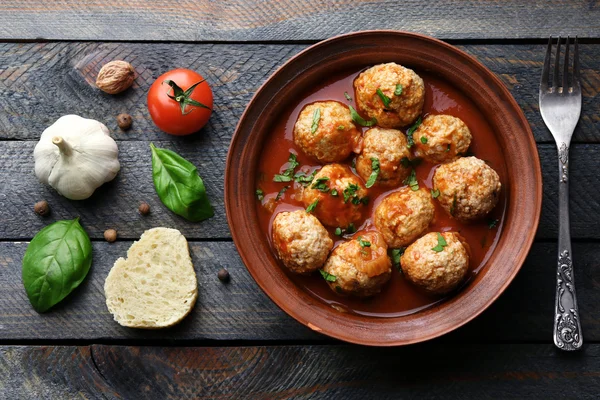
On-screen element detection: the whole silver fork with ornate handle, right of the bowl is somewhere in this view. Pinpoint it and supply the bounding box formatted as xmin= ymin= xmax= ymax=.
xmin=540 ymin=36 xmax=583 ymax=350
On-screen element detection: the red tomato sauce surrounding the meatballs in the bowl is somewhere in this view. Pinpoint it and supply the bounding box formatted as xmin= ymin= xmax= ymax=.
xmin=256 ymin=71 xmax=506 ymax=317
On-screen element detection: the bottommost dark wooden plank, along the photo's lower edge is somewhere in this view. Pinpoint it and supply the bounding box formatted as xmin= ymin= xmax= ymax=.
xmin=0 ymin=344 xmax=600 ymax=400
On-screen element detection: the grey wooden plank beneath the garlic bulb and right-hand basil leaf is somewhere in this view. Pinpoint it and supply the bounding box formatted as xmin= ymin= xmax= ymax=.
xmin=0 ymin=141 xmax=600 ymax=240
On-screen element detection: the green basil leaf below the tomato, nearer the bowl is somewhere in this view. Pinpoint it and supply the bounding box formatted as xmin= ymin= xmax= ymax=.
xmin=150 ymin=143 xmax=214 ymax=222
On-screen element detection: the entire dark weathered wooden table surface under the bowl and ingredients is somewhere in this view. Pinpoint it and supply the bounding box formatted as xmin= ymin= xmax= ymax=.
xmin=0 ymin=0 xmax=600 ymax=399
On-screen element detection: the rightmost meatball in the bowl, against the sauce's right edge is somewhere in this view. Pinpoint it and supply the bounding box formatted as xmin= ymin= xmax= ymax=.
xmin=433 ymin=157 xmax=501 ymax=222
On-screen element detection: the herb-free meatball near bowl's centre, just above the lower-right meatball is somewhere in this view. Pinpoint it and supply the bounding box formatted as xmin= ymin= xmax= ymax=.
xmin=373 ymin=186 xmax=435 ymax=248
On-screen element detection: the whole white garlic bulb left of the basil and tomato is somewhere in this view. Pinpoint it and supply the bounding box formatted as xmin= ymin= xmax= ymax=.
xmin=33 ymin=115 xmax=121 ymax=200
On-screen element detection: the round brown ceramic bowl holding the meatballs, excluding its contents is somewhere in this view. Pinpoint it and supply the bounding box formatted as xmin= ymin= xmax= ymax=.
xmin=225 ymin=31 xmax=542 ymax=346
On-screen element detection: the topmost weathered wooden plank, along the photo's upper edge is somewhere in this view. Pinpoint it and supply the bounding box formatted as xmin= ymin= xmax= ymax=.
xmin=0 ymin=0 xmax=600 ymax=41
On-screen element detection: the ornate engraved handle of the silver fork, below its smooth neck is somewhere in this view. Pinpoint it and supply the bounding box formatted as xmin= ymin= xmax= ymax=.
xmin=554 ymin=143 xmax=583 ymax=350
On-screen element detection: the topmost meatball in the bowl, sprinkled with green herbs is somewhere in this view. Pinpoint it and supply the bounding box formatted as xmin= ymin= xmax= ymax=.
xmin=354 ymin=63 xmax=425 ymax=128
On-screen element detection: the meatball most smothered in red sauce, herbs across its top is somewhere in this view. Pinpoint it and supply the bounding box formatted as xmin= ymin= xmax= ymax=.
xmin=302 ymin=164 xmax=369 ymax=228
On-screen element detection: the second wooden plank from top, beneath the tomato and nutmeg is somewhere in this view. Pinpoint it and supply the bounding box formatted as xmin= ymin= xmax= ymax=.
xmin=0 ymin=41 xmax=600 ymax=142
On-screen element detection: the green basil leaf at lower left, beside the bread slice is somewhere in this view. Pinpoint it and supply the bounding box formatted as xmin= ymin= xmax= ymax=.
xmin=23 ymin=218 xmax=92 ymax=312
